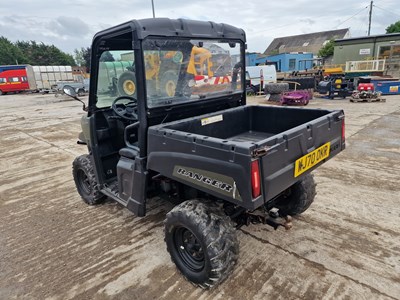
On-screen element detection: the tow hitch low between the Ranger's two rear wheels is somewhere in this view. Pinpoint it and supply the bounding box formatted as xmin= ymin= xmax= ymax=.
xmin=237 ymin=207 xmax=293 ymax=230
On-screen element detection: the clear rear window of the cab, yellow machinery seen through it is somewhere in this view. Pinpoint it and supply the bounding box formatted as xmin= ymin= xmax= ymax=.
xmin=143 ymin=38 xmax=242 ymax=107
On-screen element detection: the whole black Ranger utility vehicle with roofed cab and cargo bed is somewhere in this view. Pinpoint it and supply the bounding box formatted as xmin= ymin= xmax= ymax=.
xmin=70 ymin=19 xmax=345 ymax=288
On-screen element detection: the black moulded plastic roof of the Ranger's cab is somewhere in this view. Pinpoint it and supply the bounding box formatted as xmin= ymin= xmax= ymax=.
xmin=93 ymin=18 xmax=246 ymax=42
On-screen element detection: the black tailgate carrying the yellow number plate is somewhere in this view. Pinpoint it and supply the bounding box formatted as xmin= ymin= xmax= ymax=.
xmin=255 ymin=111 xmax=345 ymax=201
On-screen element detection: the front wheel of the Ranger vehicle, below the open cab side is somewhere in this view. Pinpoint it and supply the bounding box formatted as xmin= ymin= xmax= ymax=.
xmin=72 ymin=154 xmax=106 ymax=205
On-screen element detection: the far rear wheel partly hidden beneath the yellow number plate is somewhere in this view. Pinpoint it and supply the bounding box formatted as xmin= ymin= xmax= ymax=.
xmin=274 ymin=174 xmax=317 ymax=216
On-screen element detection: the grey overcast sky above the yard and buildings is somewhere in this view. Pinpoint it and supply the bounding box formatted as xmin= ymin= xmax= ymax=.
xmin=0 ymin=0 xmax=400 ymax=54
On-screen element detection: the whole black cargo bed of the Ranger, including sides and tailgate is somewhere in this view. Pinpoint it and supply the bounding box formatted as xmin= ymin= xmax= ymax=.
xmin=148 ymin=106 xmax=344 ymax=209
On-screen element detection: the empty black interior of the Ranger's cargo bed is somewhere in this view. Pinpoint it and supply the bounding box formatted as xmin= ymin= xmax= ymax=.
xmin=156 ymin=106 xmax=331 ymax=143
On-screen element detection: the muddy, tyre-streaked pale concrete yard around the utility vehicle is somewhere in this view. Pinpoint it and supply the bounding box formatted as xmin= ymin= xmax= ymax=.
xmin=0 ymin=95 xmax=400 ymax=299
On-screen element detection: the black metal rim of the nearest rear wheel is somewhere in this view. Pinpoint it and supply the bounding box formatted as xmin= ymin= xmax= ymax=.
xmin=174 ymin=227 xmax=205 ymax=272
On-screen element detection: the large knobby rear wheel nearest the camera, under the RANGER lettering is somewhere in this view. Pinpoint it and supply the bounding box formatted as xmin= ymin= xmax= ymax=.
xmin=164 ymin=200 xmax=239 ymax=289
